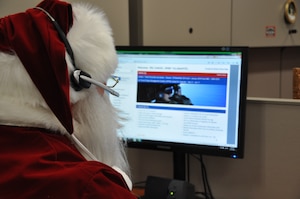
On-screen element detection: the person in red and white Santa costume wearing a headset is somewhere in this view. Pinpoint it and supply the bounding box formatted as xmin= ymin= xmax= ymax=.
xmin=0 ymin=0 xmax=135 ymax=199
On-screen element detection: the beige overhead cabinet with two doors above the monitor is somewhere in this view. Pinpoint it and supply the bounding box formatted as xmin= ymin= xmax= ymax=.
xmin=137 ymin=0 xmax=300 ymax=47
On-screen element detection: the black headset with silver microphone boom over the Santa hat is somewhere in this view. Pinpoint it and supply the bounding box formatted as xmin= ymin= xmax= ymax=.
xmin=35 ymin=7 xmax=119 ymax=97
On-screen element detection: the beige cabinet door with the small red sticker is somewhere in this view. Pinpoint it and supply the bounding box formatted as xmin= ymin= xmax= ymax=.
xmin=232 ymin=0 xmax=300 ymax=47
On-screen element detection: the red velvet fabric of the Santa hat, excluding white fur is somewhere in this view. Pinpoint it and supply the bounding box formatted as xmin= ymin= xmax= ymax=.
xmin=0 ymin=0 xmax=79 ymax=134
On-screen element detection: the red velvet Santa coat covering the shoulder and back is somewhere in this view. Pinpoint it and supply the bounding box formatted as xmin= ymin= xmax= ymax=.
xmin=0 ymin=126 xmax=134 ymax=199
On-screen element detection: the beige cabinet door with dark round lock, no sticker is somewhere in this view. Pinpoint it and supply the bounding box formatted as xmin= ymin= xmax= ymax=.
xmin=142 ymin=0 xmax=231 ymax=45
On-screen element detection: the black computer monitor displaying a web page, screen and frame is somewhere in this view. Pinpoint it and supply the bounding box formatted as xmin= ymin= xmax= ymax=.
xmin=111 ymin=46 xmax=247 ymax=158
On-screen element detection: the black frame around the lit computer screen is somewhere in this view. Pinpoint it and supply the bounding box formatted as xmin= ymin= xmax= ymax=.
xmin=116 ymin=46 xmax=248 ymax=159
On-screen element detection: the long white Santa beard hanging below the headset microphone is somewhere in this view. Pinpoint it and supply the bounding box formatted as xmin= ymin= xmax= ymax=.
xmin=72 ymin=88 xmax=129 ymax=173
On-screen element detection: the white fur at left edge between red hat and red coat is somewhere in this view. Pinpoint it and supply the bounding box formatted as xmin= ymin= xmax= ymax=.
xmin=0 ymin=49 xmax=66 ymax=134
